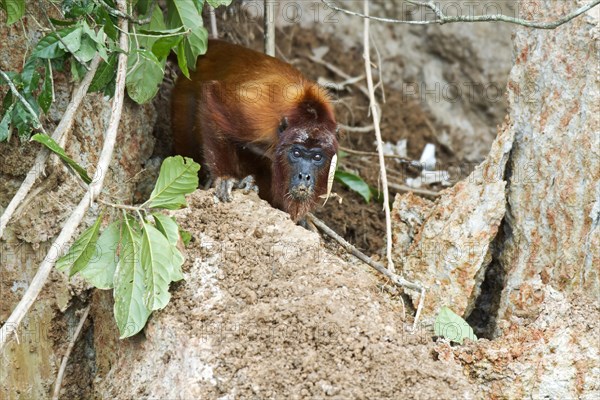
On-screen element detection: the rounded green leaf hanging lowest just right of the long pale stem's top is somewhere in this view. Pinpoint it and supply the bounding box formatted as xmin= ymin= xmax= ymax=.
xmin=125 ymin=50 xmax=164 ymax=104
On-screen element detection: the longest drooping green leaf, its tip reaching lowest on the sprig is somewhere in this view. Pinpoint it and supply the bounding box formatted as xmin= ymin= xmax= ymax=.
xmin=113 ymin=218 xmax=150 ymax=339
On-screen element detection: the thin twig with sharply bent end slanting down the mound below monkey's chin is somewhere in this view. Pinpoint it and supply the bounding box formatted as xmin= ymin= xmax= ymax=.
xmin=307 ymin=213 xmax=425 ymax=331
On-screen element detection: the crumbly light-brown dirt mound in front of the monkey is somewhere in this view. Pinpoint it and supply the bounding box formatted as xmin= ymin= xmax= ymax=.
xmin=94 ymin=191 xmax=476 ymax=399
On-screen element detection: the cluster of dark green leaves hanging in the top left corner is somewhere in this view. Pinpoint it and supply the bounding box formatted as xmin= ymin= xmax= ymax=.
xmin=0 ymin=0 xmax=231 ymax=142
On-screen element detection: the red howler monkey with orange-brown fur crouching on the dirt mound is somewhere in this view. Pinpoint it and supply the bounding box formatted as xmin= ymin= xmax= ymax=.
xmin=172 ymin=40 xmax=338 ymax=221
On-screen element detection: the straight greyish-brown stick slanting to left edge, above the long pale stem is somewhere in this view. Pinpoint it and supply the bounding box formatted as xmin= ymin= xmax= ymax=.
xmin=0 ymin=56 xmax=100 ymax=238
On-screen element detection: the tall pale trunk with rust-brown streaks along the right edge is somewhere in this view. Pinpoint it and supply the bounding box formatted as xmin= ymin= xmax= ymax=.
xmin=439 ymin=0 xmax=600 ymax=399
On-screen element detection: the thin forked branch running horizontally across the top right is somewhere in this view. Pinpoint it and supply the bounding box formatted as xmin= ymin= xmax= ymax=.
xmin=321 ymin=0 xmax=600 ymax=29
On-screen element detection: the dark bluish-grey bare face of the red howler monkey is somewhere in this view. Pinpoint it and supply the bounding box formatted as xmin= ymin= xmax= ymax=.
xmin=287 ymin=144 xmax=327 ymax=201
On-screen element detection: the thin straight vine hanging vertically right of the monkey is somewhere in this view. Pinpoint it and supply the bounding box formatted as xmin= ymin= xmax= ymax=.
xmin=364 ymin=0 xmax=396 ymax=272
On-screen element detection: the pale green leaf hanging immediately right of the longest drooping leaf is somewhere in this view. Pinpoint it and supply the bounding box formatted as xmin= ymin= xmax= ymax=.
xmin=141 ymin=222 xmax=173 ymax=311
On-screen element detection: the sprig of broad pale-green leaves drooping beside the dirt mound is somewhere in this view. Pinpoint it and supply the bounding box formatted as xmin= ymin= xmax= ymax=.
xmin=35 ymin=150 xmax=200 ymax=338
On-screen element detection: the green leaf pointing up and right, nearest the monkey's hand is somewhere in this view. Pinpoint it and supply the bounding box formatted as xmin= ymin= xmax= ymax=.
xmin=144 ymin=156 xmax=200 ymax=210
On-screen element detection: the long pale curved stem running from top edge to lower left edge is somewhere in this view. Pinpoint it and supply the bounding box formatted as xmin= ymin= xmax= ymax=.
xmin=0 ymin=0 xmax=128 ymax=351
